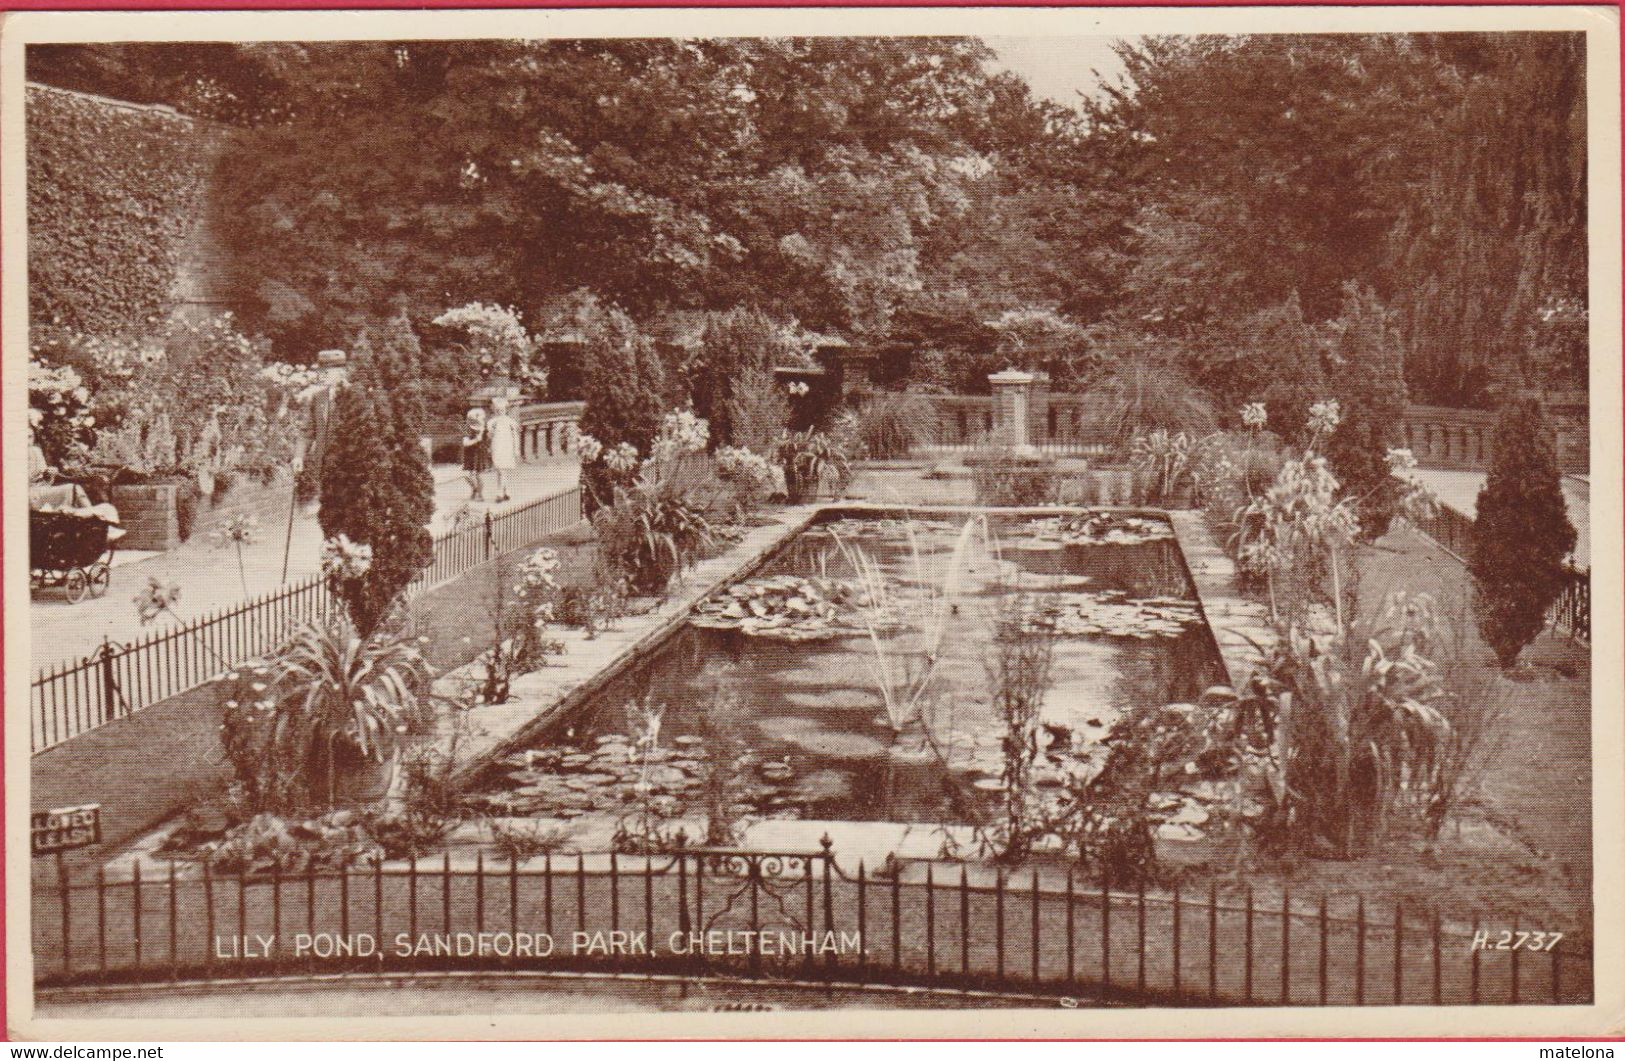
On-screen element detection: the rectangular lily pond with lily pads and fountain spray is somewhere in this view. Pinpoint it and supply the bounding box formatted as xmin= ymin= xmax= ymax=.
xmin=471 ymin=512 xmax=1224 ymax=825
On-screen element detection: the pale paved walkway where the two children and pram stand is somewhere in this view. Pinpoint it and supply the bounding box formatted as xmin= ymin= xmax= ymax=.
xmin=28 ymin=457 xmax=579 ymax=669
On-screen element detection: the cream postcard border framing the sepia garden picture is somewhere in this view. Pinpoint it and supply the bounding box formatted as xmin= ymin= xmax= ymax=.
xmin=0 ymin=6 xmax=1625 ymax=1040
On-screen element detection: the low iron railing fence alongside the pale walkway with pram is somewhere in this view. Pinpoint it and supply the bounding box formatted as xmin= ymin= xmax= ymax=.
xmin=29 ymin=486 xmax=582 ymax=752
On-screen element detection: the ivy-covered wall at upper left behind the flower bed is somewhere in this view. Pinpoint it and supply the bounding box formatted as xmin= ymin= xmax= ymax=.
xmin=28 ymin=84 xmax=211 ymax=335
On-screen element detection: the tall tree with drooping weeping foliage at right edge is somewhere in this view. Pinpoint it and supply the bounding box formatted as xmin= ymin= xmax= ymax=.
xmin=1391 ymin=32 xmax=1586 ymax=405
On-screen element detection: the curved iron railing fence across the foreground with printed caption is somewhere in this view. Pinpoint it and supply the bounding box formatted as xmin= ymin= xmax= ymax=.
xmin=33 ymin=840 xmax=1593 ymax=1006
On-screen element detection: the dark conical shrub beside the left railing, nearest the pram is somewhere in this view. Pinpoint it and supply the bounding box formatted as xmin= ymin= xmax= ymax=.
xmin=319 ymin=382 xmax=434 ymax=635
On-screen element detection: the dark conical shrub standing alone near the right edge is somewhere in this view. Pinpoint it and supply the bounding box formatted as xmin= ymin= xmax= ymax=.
xmin=1467 ymin=398 xmax=1576 ymax=668
